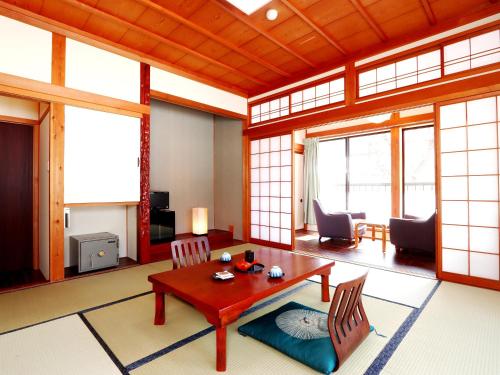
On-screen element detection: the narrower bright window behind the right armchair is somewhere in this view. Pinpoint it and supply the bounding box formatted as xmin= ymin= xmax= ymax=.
xmin=403 ymin=126 xmax=436 ymax=217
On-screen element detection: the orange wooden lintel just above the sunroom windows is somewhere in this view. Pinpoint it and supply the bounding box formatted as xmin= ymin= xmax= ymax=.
xmin=306 ymin=113 xmax=434 ymax=138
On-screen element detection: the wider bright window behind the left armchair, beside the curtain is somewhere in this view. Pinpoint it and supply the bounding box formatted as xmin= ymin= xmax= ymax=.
xmin=318 ymin=133 xmax=391 ymax=223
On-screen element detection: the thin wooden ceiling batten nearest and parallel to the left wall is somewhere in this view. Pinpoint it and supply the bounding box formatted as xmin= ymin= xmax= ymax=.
xmin=63 ymin=0 xmax=268 ymax=86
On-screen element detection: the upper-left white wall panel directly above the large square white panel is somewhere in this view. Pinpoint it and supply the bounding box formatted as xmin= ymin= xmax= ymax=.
xmin=66 ymin=38 xmax=141 ymax=103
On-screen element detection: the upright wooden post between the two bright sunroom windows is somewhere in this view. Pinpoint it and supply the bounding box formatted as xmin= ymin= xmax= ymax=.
xmin=391 ymin=128 xmax=403 ymax=217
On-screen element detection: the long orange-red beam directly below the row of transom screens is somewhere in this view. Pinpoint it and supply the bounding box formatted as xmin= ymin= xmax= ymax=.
xmin=244 ymin=72 xmax=500 ymax=138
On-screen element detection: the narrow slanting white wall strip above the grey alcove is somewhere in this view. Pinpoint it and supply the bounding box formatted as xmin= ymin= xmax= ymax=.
xmin=151 ymin=67 xmax=247 ymax=115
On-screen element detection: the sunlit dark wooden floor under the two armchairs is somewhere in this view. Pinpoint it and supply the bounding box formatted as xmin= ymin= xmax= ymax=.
xmin=295 ymin=230 xmax=436 ymax=277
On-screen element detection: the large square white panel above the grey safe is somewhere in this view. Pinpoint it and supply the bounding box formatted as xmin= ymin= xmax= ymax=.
xmin=64 ymin=106 xmax=140 ymax=203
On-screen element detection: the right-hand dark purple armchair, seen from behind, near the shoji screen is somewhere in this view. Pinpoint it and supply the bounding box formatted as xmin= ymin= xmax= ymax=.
xmin=389 ymin=214 xmax=436 ymax=256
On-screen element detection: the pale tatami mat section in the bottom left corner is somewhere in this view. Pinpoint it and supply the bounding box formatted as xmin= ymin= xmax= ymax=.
xmin=0 ymin=315 xmax=120 ymax=375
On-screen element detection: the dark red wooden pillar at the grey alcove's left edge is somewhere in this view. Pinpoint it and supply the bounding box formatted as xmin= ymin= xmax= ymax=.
xmin=137 ymin=63 xmax=151 ymax=264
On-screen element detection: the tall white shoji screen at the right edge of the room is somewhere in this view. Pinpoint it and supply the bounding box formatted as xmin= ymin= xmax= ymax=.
xmin=438 ymin=96 xmax=500 ymax=282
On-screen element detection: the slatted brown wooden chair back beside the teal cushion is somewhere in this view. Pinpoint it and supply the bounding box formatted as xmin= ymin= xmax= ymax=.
xmin=328 ymin=273 xmax=370 ymax=370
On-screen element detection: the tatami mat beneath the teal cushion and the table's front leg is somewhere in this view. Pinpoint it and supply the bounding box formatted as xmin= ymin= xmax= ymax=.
xmin=131 ymin=283 xmax=411 ymax=375
